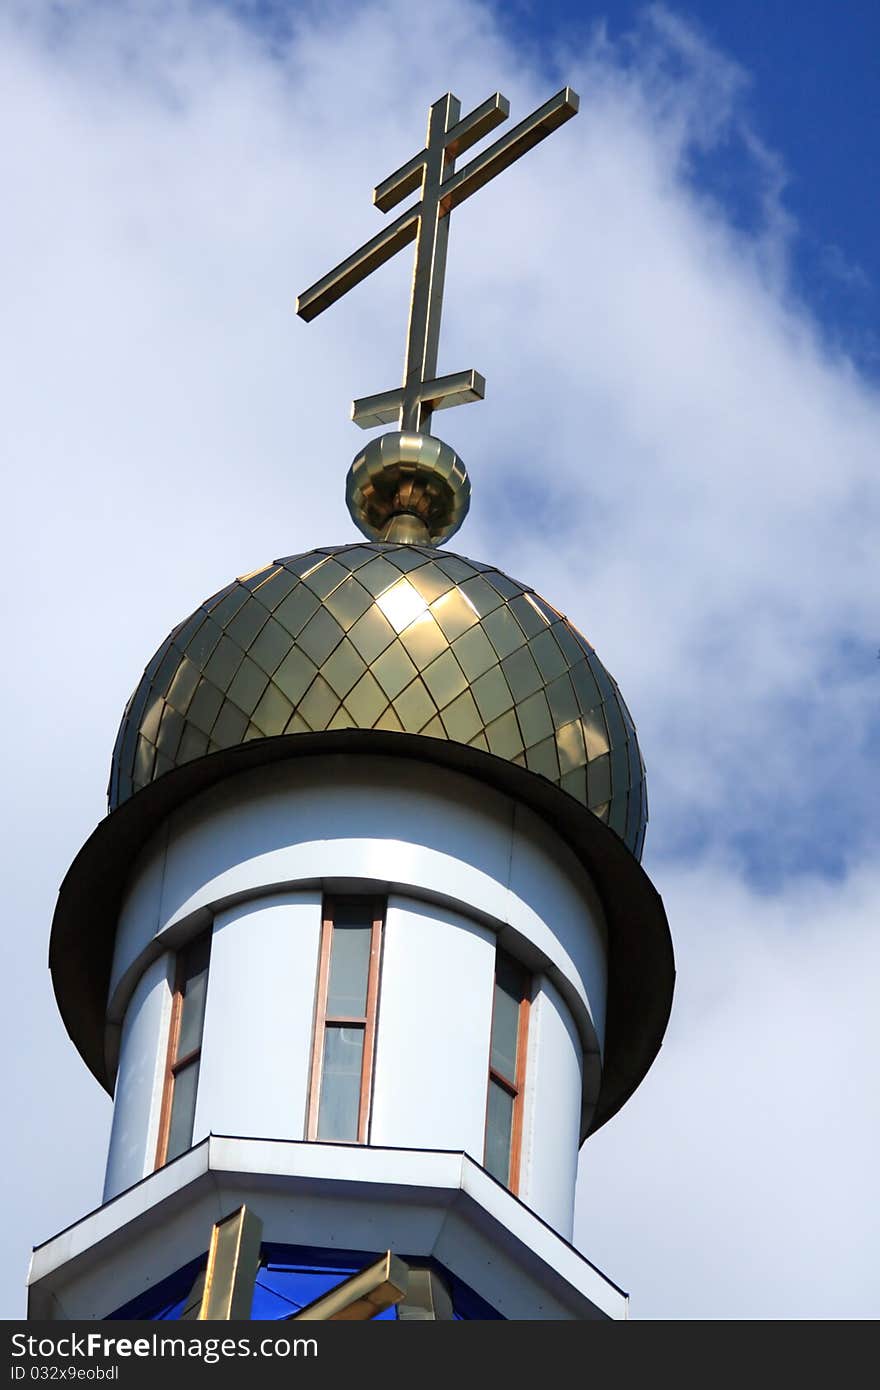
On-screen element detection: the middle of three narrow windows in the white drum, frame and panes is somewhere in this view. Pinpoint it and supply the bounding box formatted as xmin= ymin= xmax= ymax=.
xmin=307 ymin=898 xmax=384 ymax=1144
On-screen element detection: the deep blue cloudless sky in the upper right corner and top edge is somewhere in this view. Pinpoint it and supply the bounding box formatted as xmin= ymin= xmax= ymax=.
xmin=503 ymin=0 xmax=880 ymax=375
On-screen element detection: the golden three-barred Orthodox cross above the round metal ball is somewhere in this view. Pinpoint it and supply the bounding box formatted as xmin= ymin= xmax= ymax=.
xmin=296 ymin=88 xmax=578 ymax=432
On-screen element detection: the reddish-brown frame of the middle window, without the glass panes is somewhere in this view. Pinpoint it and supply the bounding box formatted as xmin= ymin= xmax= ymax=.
xmin=306 ymin=892 xmax=388 ymax=1144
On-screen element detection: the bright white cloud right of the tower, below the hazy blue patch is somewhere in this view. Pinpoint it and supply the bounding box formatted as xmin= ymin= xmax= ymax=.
xmin=578 ymin=863 xmax=880 ymax=1319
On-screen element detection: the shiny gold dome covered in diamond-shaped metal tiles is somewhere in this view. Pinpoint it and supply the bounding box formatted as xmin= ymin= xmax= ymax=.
xmin=110 ymin=542 xmax=648 ymax=858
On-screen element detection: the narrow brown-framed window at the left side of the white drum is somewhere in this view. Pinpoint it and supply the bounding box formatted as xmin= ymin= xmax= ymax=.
xmin=156 ymin=931 xmax=211 ymax=1168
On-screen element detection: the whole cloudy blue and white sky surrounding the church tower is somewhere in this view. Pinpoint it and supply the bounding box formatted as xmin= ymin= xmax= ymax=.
xmin=0 ymin=0 xmax=880 ymax=1318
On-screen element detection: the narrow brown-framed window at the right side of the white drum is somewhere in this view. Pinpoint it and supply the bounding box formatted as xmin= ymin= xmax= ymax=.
xmin=482 ymin=951 xmax=528 ymax=1193
